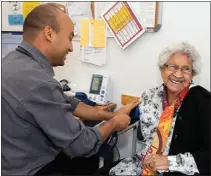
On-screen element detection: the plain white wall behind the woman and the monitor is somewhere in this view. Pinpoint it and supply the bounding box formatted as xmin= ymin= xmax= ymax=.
xmin=55 ymin=2 xmax=210 ymax=108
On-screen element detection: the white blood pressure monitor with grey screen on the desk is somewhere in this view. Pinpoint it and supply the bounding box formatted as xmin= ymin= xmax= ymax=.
xmin=88 ymin=74 xmax=110 ymax=105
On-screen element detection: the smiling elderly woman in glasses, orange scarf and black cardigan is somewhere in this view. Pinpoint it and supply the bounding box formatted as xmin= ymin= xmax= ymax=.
xmin=95 ymin=42 xmax=211 ymax=175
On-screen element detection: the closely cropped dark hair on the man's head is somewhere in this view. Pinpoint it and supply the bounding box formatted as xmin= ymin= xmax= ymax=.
xmin=23 ymin=3 xmax=62 ymax=39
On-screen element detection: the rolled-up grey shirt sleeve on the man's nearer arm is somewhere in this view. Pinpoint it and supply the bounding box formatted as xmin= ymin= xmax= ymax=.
xmin=22 ymin=82 xmax=102 ymax=158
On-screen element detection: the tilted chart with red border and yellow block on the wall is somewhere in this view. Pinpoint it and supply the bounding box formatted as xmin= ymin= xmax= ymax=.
xmin=102 ymin=2 xmax=146 ymax=49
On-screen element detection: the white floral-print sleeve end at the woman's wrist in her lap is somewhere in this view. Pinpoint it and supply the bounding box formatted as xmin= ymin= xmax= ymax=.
xmin=168 ymin=152 xmax=199 ymax=175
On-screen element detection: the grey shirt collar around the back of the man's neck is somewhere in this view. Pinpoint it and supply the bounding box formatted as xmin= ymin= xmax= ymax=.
xmin=19 ymin=40 xmax=54 ymax=76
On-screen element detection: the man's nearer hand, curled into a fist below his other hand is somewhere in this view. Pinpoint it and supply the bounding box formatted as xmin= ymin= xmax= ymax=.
xmin=111 ymin=114 xmax=130 ymax=131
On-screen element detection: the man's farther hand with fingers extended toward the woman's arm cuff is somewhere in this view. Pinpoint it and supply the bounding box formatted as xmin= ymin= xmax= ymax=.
xmin=114 ymin=99 xmax=141 ymax=115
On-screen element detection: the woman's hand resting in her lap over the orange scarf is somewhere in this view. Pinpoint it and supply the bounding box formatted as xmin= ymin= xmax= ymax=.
xmin=143 ymin=154 xmax=168 ymax=171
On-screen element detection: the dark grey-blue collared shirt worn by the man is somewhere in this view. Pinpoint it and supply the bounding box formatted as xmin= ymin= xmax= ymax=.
xmin=1 ymin=41 xmax=101 ymax=175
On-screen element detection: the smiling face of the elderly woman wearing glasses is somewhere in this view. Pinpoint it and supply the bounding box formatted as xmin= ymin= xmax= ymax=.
xmin=160 ymin=53 xmax=193 ymax=94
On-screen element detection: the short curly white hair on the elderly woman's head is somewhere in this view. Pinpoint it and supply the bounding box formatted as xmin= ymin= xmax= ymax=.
xmin=158 ymin=42 xmax=201 ymax=76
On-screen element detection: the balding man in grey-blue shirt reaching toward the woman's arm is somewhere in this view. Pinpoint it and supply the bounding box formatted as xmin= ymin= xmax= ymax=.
xmin=2 ymin=3 xmax=140 ymax=175
